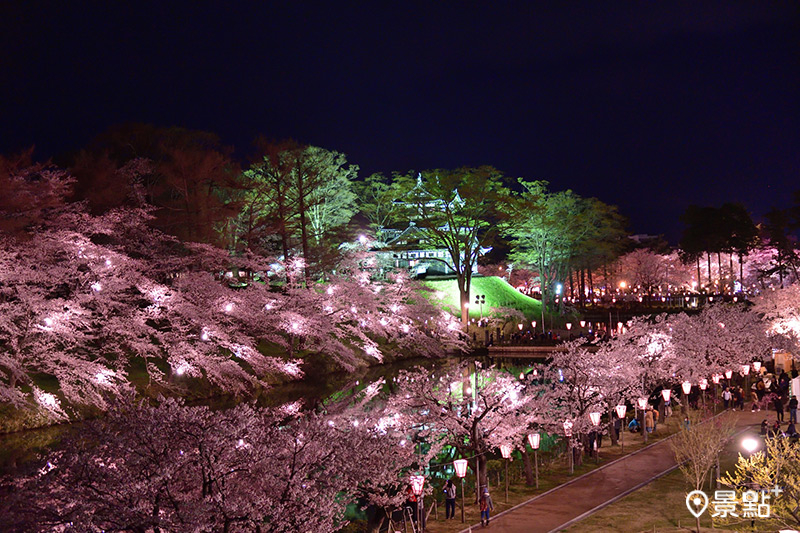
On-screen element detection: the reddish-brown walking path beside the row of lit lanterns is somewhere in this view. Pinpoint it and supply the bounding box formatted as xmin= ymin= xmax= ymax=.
xmin=461 ymin=411 xmax=774 ymax=533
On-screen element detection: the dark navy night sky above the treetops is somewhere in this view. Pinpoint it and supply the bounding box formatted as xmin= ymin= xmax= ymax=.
xmin=0 ymin=2 xmax=800 ymax=240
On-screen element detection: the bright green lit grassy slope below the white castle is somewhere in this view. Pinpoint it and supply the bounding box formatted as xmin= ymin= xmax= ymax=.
xmin=424 ymin=276 xmax=542 ymax=319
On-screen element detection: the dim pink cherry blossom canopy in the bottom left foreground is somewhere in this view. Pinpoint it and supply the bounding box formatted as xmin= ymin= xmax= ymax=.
xmin=0 ymin=400 xmax=416 ymax=533
